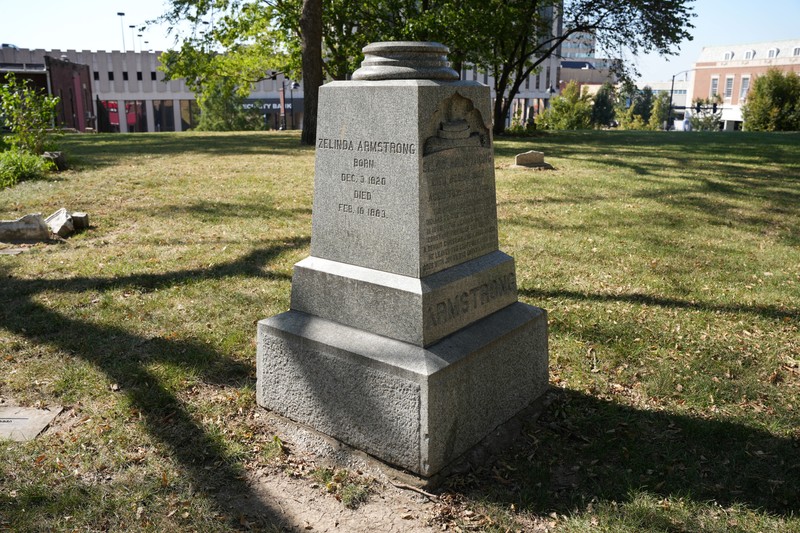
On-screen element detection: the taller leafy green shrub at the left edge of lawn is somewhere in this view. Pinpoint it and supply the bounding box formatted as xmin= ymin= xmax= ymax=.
xmin=0 ymin=73 xmax=59 ymax=155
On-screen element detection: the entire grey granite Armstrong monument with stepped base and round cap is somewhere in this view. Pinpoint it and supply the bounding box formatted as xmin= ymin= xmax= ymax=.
xmin=257 ymin=42 xmax=548 ymax=478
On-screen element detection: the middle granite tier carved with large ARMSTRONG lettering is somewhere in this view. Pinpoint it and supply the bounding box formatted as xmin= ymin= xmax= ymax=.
xmin=291 ymin=251 xmax=517 ymax=346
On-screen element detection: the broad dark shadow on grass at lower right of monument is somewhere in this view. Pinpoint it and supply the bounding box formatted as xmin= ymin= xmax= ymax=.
xmin=450 ymin=389 xmax=800 ymax=517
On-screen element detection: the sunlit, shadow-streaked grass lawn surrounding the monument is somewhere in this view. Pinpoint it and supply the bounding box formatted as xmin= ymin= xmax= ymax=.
xmin=0 ymin=132 xmax=800 ymax=532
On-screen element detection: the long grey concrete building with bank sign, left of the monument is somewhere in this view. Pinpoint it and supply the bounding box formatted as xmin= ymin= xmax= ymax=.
xmin=0 ymin=48 xmax=303 ymax=133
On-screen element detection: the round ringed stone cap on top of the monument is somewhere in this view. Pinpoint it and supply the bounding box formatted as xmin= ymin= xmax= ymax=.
xmin=353 ymin=41 xmax=460 ymax=81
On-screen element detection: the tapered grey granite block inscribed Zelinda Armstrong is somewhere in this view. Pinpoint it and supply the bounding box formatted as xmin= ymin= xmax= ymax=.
xmin=311 ymin=80 xmax=498 ymax=277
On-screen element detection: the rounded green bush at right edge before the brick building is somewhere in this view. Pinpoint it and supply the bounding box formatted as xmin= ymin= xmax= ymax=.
xmin=742 ymin=69 xmax=800 ymax=131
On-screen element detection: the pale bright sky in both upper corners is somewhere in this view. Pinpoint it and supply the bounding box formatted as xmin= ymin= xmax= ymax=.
xmin=0 ymin=0 xmax=800 ymax=82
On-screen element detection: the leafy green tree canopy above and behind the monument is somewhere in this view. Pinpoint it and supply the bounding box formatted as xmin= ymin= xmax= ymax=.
xmin=156 ymin=0 xmax=694 ymax=139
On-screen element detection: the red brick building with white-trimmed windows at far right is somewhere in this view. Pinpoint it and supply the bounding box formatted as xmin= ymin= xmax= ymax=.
xmin=692 ymin=39 xmax=800 ymax=130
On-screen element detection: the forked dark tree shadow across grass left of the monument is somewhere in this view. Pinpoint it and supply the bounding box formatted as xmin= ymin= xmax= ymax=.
xmin=0 ymin=237 xmax=309 ymax=529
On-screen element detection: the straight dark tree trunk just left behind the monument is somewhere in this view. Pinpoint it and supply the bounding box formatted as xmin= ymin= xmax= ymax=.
xmin=300 ymin=0 xmax=322 ymax=146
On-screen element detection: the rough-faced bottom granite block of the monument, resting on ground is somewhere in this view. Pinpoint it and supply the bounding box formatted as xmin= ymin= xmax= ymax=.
xmin=257 ymin=302 xmax=548 ymax=477
